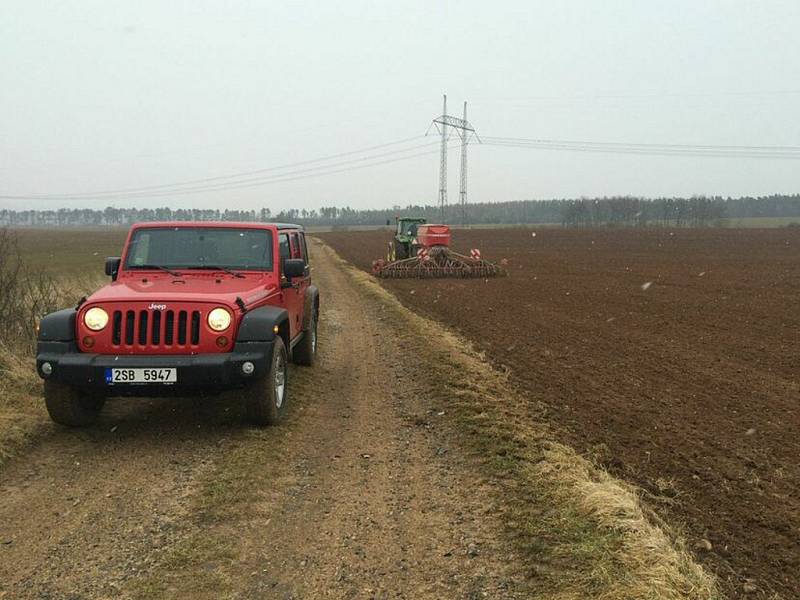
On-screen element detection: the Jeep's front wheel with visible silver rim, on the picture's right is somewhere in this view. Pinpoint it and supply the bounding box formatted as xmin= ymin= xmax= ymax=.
xmin=245 ymin=337 xmax=289 ymax=427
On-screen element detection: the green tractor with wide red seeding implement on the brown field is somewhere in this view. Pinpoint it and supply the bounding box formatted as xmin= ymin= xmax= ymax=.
xmin=372 ymin=219 xmax=503 ymax=278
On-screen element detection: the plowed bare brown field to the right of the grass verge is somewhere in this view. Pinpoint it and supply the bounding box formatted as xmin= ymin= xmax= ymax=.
xmin=319 ymin=229 xmax=800 ymax=599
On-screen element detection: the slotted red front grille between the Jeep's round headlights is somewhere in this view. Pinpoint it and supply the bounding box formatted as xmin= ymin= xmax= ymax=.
xmin=111 ymin=310 xmax=201 ymax=346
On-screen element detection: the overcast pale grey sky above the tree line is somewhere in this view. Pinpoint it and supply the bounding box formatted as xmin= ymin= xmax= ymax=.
xmin=0 ymin=0 xmax=800 ymax=210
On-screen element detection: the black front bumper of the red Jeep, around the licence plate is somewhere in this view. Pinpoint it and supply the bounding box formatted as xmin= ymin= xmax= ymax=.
xmin=36 ymin=341 xmax=274 ymax=396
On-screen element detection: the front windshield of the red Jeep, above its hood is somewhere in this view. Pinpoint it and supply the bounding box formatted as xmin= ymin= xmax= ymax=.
xmin=125 ymin=227 xmax=272 ymax=271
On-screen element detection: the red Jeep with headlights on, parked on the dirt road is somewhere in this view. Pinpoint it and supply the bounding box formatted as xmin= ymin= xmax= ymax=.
xmin=36 ymin=222 xmax=319 ymax=426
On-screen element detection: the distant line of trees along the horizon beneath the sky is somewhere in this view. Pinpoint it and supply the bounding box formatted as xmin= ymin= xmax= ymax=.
xmin=0 ymin=194 xmax=800 ymax=227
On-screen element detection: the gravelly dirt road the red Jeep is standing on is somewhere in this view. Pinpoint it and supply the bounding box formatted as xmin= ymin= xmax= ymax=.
xmin=0 ymin=241 xmax=527 ymax=599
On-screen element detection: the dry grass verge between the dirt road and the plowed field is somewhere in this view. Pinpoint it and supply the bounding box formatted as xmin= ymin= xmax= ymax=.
xmin=322 ymin=239 xmax=721 ymax=600
